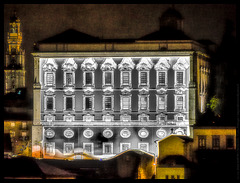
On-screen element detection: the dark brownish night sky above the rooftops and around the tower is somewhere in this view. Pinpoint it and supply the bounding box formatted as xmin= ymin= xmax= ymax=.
xmin=4 ymin=4 xmax=236 ymax=96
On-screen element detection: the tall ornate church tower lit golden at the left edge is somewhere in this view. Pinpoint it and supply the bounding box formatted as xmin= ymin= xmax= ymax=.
xmin=4 ymin=11 xmax=26 ymax=94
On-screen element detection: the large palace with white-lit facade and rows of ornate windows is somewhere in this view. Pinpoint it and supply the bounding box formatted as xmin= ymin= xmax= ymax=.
xmin=32 ymin=7 xmax=209 ymax=158
